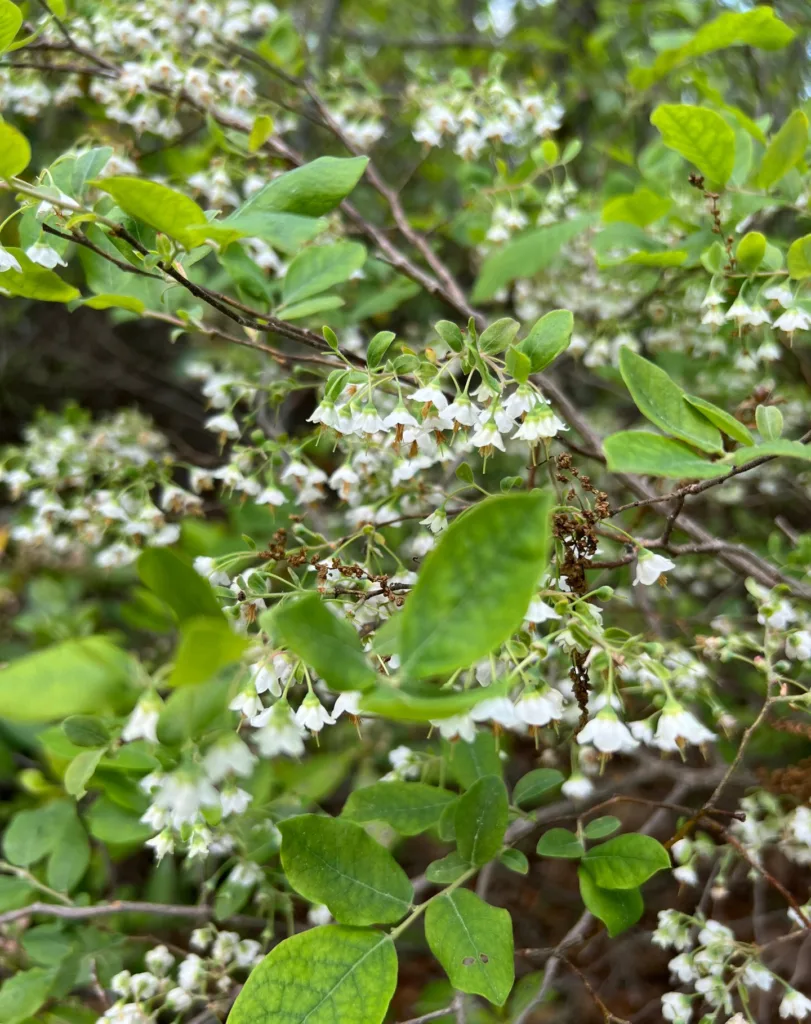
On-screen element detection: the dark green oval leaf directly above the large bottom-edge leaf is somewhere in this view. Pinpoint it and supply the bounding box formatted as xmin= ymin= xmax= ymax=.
xmin=280 ymin=814 xmax=414 ymax=925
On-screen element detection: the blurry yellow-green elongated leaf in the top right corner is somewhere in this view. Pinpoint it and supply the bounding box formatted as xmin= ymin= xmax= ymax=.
xmin=629 ymin=6 xmax=795 ymax=89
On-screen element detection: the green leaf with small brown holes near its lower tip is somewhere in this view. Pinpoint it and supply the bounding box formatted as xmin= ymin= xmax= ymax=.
xmin=425 ymin=889 xmax=515 ymax=1007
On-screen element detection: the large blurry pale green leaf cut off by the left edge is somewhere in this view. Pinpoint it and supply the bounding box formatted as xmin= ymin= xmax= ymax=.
xmin=0 ymin=637 xmax=130 ymax=722
